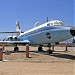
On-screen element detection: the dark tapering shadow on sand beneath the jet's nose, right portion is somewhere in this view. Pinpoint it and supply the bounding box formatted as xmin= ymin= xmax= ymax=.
xmin=36 ymin=51 xmax=75 ymax=60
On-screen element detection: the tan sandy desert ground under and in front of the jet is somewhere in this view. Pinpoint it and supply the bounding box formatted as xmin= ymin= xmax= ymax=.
xmin=0 ymin=46 xmax=75 ymax=75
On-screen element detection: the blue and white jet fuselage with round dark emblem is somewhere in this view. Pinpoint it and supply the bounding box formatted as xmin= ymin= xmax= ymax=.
xmin=18 ymin=21 xmax=75 ymax=44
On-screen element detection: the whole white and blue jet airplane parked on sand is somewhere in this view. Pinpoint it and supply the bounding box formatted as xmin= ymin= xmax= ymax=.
xmin=0 ymin=20 xmax=75 ymax=49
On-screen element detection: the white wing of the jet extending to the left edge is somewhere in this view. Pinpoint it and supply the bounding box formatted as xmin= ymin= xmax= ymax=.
xmin=0 ymin=40 xmax=30 ymax=45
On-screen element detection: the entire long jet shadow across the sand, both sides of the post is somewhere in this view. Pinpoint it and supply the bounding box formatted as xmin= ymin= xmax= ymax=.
xmin=3 ymin=51 xmax=75 ymax=60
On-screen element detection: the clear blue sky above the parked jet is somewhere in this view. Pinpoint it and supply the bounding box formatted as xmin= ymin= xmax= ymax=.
xmin=0 ymin=0 xmax=75 ymax=38
